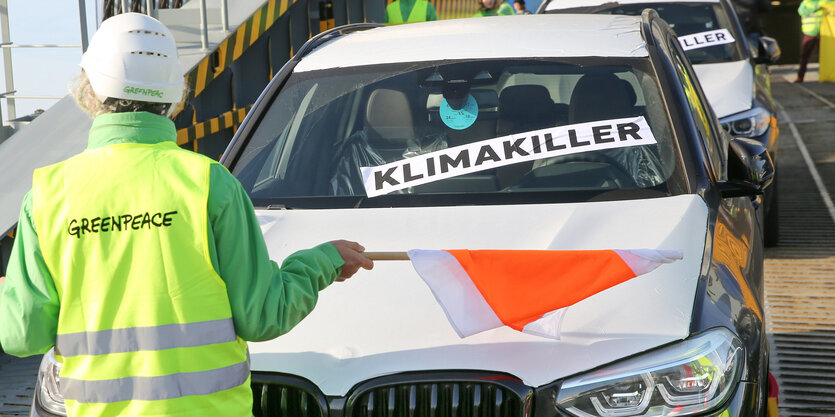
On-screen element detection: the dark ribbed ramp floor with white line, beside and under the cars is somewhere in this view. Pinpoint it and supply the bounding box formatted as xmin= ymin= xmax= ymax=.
xmin=0 ymin=65 xmax=835 ymax=417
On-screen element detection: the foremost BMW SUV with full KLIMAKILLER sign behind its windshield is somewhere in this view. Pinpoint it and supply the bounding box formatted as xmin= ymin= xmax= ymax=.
xmin=34 ymin=10 xmax=773 ymax=417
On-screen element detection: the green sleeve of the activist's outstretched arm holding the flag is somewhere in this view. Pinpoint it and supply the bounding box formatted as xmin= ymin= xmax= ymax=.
xmin=208 ymin=164 xmax=344 ymax=341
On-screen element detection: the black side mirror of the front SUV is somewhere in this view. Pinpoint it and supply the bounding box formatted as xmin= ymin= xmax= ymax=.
xmin=719 ymin=138 xmax=774 ymax=198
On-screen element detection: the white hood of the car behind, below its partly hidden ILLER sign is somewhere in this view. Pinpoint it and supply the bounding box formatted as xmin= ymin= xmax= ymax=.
xmin=693 ymin=60 xmax=754 ymax=118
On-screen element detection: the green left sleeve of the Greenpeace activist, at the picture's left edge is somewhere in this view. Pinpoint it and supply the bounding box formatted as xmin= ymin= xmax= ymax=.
xmin=0 ymin=192 xmax=61 ymax=357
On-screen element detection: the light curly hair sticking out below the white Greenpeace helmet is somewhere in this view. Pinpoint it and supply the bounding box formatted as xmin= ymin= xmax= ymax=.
xmin=70 ymin=70 xmax=188 ymax=117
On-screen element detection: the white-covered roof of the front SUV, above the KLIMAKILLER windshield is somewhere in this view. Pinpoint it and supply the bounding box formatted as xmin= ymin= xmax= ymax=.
xmin=294 ymin=15 xmax=648 ymax=72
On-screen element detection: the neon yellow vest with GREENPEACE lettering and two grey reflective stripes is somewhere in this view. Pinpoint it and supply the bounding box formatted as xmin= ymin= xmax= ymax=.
xmin=32 ymin=142 xmax=252 ymax=416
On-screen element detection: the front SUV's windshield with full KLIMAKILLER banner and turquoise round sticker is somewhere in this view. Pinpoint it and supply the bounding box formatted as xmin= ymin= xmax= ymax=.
xmin=232 ymin=58 xmax=686 ymax=208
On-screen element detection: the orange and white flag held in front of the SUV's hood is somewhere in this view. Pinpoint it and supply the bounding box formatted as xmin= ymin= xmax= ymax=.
xmin=408 ymin=249 xmax=683 ymax=339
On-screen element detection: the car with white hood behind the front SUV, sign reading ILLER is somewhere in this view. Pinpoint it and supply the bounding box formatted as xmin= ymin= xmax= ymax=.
xmin=537 ymin=0 xmax=780 ymax=246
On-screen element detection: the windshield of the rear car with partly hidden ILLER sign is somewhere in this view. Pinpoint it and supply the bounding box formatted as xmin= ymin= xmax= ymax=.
xmin=546 ymin=0 xmax=743 ymax=64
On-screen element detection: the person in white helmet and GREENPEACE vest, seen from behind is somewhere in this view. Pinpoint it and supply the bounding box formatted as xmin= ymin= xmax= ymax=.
xmin=0 ymin=13 xmax=373 ymax=417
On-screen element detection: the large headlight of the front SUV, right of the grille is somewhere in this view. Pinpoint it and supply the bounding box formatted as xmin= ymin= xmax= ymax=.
xmin=555 ymin=328 xmax=745 ymax=417
